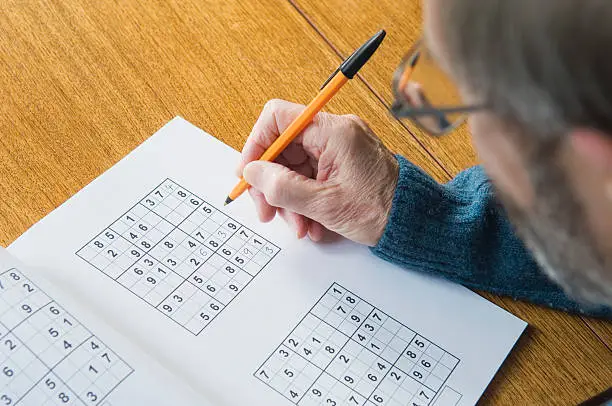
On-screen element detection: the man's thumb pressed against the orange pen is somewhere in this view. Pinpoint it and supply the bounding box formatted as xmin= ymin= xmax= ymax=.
xmin=242 ymin=161 xmax=323 ymax=217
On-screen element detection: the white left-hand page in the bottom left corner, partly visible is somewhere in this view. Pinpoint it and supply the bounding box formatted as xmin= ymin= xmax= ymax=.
xmin=0 ymin=248 xmax=209 ymax=406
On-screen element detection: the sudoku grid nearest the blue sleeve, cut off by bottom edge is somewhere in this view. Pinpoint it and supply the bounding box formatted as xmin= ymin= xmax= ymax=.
xmin=254 ymin=283 xmax=459 ymax=406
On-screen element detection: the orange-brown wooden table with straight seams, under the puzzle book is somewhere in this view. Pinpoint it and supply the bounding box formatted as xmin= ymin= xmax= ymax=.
xmin=0 ymin=0 xmax=612 ymax=405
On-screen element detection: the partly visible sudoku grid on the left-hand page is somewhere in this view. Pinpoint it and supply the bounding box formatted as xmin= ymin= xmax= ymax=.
xmin=0 ymin=268 xmax=133 ymax=406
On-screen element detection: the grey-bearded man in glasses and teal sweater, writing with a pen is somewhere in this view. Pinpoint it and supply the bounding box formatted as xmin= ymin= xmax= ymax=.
xmin=239 ymin=0 xmax=612 ymax=317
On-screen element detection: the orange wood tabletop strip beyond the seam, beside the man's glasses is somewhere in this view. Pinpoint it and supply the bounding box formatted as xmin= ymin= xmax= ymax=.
xmin=291 ymin=0 xmax=476 ymax=179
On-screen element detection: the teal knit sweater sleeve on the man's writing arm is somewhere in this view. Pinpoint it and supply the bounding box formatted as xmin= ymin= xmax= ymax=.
xmin=372 ymin=156 xmax=612 ymax=318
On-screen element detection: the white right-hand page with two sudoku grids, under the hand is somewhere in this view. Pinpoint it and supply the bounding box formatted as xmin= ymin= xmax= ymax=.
xmin=9 ymin=118 xmax=526 ymax=405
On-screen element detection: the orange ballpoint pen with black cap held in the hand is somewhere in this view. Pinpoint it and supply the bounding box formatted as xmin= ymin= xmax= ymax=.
xmin=225 ymin=30 xmax=386 ymax=205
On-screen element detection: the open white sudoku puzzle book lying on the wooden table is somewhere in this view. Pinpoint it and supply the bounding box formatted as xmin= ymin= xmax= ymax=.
xmin=0 ymin=118 xmax=526 ymax=406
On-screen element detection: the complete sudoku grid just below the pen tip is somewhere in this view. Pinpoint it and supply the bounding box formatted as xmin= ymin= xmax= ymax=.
xmin=77 ymin=179 xmax=280 ymax=335
